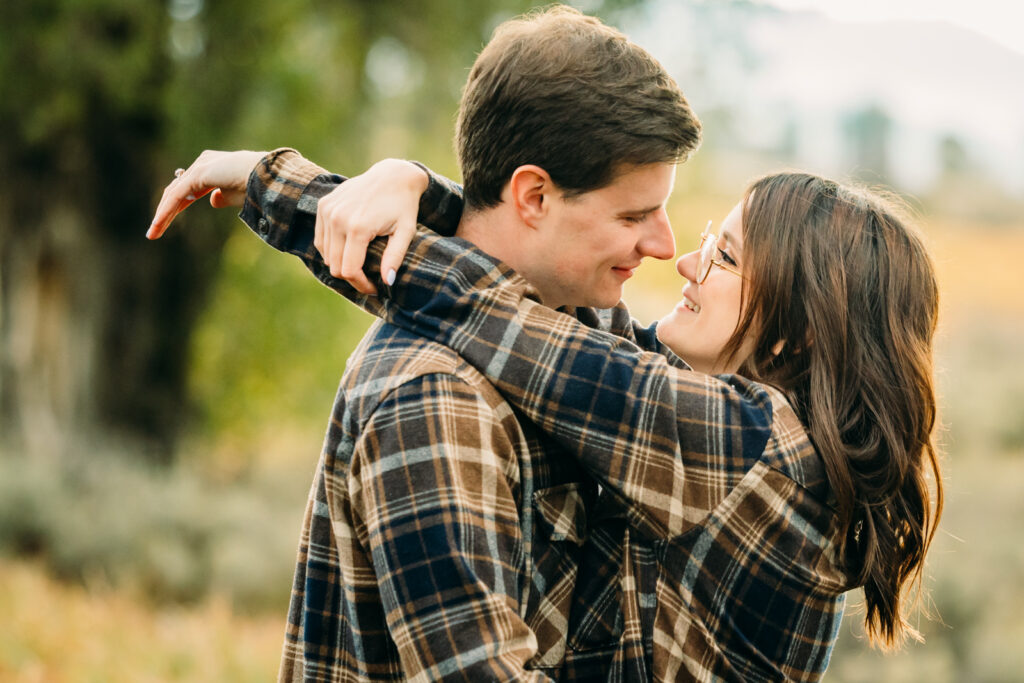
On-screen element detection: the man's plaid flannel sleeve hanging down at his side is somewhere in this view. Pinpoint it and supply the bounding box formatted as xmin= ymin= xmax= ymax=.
xmin=348 ymin=374 xmax=561 ymax=683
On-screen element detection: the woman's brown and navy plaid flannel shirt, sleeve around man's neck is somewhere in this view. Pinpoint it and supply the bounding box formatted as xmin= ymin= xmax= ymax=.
xmin=239 ymin=152 xmax=851 ymax=681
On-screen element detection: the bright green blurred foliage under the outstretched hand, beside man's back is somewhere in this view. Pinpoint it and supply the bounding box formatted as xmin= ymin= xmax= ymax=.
xmin=189 ymin=221 xmax=371 ymax=438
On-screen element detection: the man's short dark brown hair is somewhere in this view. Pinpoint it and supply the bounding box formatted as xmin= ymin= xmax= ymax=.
xmin=456 ymin=5 xmax=700 ymax=210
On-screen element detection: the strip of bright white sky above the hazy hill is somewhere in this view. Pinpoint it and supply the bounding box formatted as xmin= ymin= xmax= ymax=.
xmin=764 ymin=0 xmax=1024 ymax=54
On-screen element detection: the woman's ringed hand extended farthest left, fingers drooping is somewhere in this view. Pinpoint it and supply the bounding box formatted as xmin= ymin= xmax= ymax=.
xmin=145 ymin=150 xmax=266 ymax=240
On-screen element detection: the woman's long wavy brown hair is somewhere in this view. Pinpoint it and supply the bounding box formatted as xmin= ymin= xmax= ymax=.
xmin=725 ymin=173 xmax=942 ymax=648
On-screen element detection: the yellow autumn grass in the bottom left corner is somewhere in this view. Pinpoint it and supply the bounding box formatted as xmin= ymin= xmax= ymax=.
xmin=0 ymin=560 xmax=284 ymax=683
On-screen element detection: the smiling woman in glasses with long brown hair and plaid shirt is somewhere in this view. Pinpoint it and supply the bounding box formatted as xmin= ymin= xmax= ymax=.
xmin=303 ymin=160 xmax=942 ymax=680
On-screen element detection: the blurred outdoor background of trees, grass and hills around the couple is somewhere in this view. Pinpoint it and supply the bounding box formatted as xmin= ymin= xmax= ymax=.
xmin=0 ymin=0 xmax=1024 ymax=683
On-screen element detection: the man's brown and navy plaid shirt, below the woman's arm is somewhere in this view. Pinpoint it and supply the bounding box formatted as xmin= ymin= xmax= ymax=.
xmin=281 ymin=324 xmax=615 ymax=681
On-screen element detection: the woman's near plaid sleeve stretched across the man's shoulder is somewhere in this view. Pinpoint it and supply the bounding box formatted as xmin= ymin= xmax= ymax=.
xmin=352 ymin=231 xmax=773 ymax=538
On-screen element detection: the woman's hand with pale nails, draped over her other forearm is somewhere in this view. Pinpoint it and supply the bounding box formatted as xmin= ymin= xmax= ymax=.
xmin=313 ymin=159 xmax=429 ymax=295
